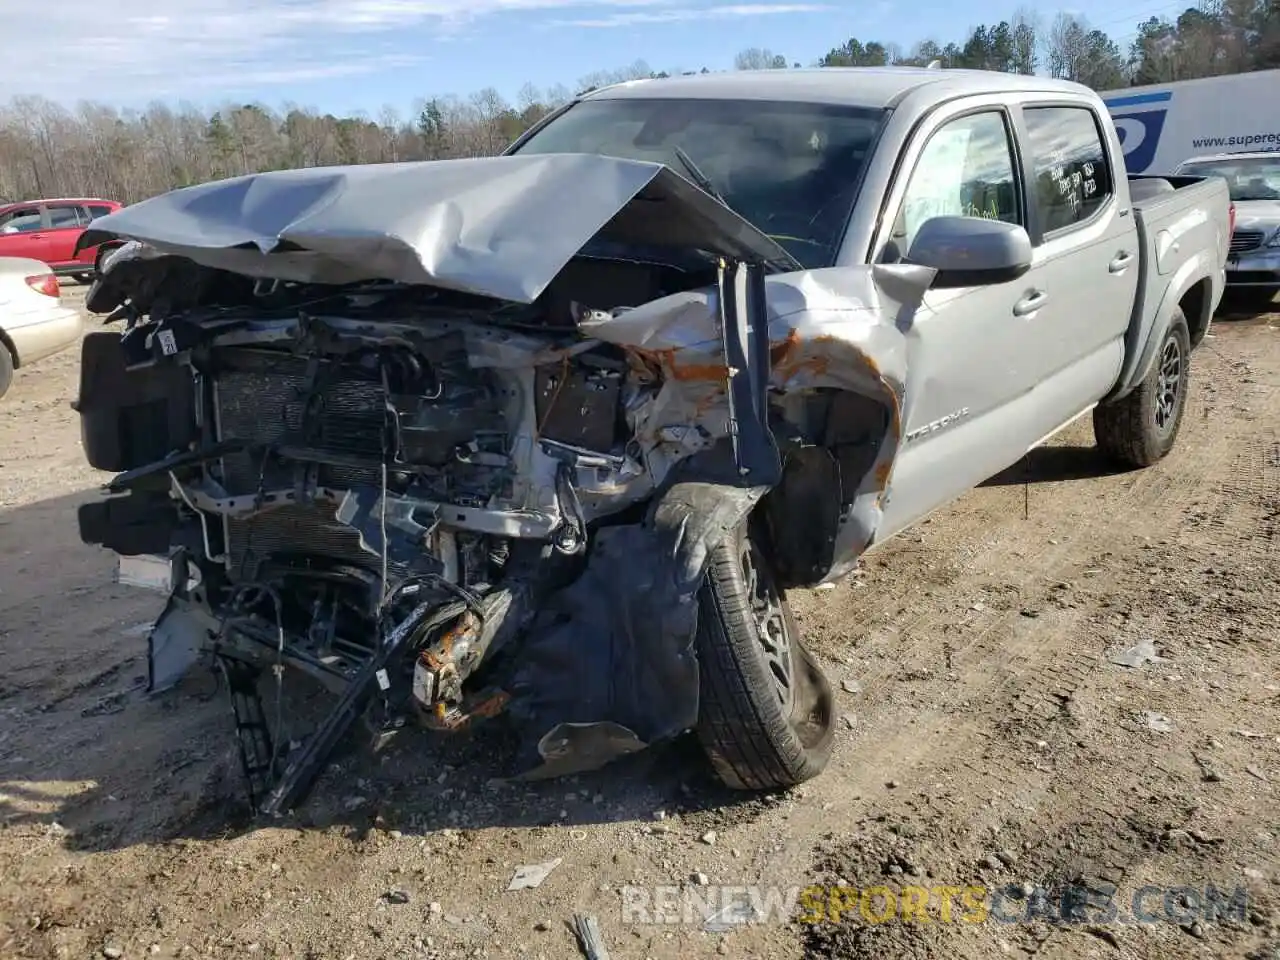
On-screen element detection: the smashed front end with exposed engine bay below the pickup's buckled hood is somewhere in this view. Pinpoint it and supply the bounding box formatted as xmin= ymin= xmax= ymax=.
xmin=77 ymin=157 xmax=927 ymax=813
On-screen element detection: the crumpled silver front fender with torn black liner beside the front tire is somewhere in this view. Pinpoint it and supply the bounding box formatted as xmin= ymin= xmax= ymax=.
xmin=511 ymin=266 xmax=933 ymax=778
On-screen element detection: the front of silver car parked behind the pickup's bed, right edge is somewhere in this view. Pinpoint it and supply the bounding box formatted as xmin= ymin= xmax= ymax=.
xmin=1178 ymin=152 xmax=1280 ymax=291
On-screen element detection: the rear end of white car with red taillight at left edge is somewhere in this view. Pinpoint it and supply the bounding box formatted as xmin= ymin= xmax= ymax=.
xmin=0 ymin=257 xmax=84 ymax=397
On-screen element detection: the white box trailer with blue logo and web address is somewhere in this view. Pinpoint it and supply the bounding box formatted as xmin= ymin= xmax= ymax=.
xmin=1102 ymin=70 xmax=1280 ymax=174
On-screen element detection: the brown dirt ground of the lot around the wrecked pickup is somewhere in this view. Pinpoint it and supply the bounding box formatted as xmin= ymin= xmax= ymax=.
xmin=0 ymin=287 xmax=1280 ymax=960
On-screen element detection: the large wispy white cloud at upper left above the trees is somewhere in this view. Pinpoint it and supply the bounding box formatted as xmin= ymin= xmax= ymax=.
xmin=0 ymin=0 xmax=721 ymax=102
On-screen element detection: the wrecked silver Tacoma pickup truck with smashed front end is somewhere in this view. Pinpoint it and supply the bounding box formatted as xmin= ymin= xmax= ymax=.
xmin=77 ymin=69 xmax=1230 ymax=813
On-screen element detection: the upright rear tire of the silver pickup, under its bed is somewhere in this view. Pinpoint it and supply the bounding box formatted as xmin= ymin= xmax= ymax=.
xmin=1093 ymin=308 xmax=1192 ymax=467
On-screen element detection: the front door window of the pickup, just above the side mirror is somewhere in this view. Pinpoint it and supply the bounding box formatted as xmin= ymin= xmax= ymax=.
xmin=882 ymin=110 xmax=1023 ymax=261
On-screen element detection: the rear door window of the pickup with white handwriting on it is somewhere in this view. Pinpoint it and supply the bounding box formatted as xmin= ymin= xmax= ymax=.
xmin=1023 ymin=106 xmax=1115 ymax=233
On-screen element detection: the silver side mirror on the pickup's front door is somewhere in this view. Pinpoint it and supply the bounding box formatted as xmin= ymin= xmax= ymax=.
xmin=906 ymin=216 xmax=1032 ymax=287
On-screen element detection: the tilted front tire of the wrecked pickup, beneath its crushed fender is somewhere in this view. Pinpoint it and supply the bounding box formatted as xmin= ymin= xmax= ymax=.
xmin=698 ymin=524 xmax=835 ymax=790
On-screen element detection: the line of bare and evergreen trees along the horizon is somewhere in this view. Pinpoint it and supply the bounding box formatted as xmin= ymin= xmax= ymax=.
xmin=0 ymin=8 xmax=1280 ymax=202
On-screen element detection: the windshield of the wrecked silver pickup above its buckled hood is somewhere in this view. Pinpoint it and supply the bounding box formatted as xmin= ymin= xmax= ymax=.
xmin=504 ymin=99 xmax=884 ymax=269
